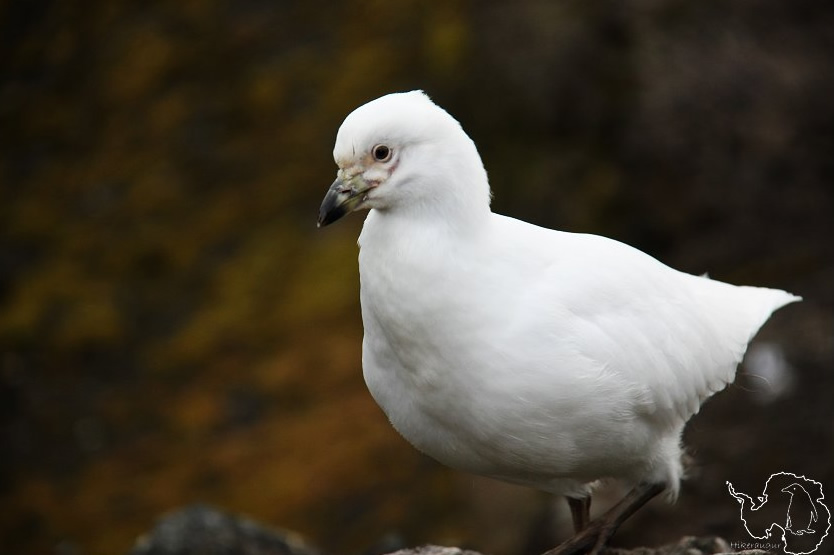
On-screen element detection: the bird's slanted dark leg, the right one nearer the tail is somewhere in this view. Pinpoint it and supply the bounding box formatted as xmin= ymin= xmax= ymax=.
xmin=542 ymin=483 xmax=665 ymax=555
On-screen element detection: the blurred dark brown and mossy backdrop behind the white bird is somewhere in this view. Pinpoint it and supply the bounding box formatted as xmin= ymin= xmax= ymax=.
xmin=0 ymin=0 xmax=834 ymax=555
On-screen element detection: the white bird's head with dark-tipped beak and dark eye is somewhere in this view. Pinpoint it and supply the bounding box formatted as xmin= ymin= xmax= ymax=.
xmin=318 ymin=91 xmax=489 ymax=227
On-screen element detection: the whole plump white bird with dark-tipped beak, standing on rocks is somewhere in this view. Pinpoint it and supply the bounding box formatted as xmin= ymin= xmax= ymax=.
xmin=319 ymin=91 xmax=800 ymax=553
